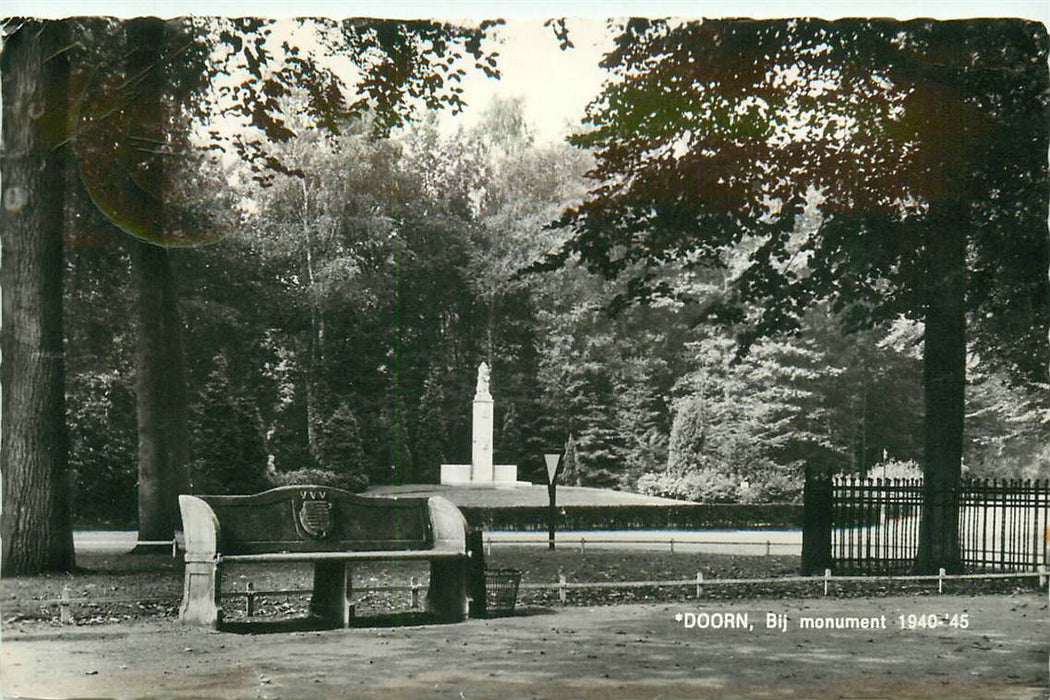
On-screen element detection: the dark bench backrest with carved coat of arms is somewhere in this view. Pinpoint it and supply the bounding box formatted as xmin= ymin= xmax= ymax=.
xmin=183 ymin=486 xmax=435 ymax=554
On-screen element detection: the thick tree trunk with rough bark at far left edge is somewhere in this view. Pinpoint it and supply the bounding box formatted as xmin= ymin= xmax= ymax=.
xmin=0 ymin=22 xmax=75 ymax=576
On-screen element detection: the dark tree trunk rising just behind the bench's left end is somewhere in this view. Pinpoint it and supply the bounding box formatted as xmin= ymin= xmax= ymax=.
xmin=127 ymin=18 xmax=189 ymax=540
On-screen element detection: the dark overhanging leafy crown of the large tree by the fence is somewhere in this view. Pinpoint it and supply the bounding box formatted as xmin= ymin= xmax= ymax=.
xmin=557 ymin=19 xmax=1050 ymax=374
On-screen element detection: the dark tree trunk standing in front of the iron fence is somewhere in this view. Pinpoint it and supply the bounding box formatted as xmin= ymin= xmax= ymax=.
xmin=917 ymin=199 xmax=966 ymax=573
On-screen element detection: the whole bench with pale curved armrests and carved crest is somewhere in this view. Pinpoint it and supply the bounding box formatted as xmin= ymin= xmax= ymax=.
xmin=179 ymin=486 xmax=469 ymax=628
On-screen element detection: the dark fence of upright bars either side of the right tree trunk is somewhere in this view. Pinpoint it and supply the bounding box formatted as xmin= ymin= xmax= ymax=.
xmin=814 ymin=476 xmax=1050 ymax=574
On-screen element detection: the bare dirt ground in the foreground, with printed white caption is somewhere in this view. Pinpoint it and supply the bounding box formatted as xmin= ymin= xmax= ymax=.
xmin=0 ymin=592 xmax=1050 ymax=698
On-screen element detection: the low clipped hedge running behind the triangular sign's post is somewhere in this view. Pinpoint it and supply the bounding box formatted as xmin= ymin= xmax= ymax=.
xmin=460 ymin=503 xmax=802 ymax=531
